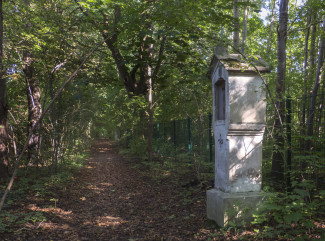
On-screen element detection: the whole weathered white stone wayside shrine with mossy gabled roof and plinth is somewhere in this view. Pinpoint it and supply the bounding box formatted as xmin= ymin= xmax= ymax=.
xmin=207 ymin=47 xmax=269 ymax=227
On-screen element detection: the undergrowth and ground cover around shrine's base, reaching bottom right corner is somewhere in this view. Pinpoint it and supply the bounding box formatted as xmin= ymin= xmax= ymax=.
xmin=205 ymin=180 xmax=325 ymax=241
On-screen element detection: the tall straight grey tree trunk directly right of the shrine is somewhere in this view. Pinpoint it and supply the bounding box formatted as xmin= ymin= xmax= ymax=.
xmin=271 ymin=0 xmax=289 ymax=186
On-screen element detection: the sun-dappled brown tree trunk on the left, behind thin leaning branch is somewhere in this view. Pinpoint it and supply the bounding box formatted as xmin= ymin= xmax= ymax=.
xmin=23 ymin=52 xmax=42 ymax=164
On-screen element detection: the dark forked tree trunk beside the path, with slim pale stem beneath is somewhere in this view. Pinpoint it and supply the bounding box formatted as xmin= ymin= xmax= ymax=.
xmin=75 ymin=0 xmax=166 ymax=161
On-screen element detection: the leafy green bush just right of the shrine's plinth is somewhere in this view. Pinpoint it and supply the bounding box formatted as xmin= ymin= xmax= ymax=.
xmin=253 ymin=181 xmax=325 ymax=240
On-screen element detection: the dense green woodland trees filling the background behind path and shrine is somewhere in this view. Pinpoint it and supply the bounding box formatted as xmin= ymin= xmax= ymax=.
xmin=0 ymin=0 xmax=325 ymax=238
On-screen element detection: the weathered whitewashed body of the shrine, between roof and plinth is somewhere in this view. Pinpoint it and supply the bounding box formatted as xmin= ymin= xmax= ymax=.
xmin=212 ymin=63 xmax=266 ymax=192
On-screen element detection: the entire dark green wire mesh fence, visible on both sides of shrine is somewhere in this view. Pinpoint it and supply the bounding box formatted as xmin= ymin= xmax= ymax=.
xmin=154 ymin=94 xmax=325 ymax=186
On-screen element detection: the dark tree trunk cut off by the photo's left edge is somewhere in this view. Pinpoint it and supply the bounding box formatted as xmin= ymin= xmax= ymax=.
xmin=0 ymin=0 xmax=9 ymax=180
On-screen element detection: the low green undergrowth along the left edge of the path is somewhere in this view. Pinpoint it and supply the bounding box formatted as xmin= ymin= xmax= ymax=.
xmin=0 ymin=152 xmax=88 ymax=234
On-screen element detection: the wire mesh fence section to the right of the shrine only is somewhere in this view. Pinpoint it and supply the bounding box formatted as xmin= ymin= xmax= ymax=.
xmin=263 ymin=94 xmax=325 ymax=188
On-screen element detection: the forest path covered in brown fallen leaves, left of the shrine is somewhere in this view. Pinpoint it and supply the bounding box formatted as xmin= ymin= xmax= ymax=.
xmin=5 ymin=140 xmax=215 ymax=241
